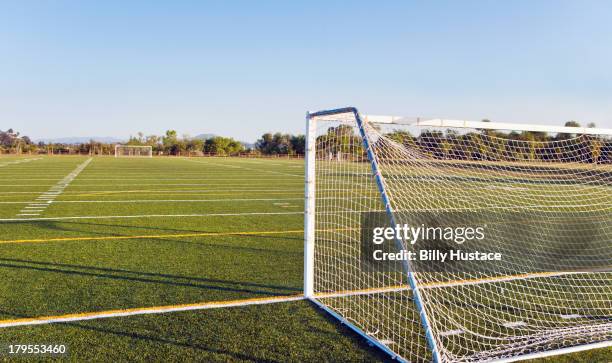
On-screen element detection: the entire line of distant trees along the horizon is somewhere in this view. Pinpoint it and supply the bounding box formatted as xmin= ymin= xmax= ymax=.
xmin=0 ymin=120 xmax=612 ymax=163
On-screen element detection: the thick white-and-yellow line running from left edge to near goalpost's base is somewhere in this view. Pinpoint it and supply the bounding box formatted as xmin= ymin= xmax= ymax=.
xmin=0 ymin=294 xmax=305 ymax=328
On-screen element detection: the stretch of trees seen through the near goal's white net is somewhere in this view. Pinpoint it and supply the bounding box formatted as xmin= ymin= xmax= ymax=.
xmin=317 ymin=121 xmax=612 ymax=164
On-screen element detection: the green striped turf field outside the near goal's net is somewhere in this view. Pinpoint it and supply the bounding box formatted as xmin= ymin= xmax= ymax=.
xmin=0 ymin=156 xmax=612 ymax=362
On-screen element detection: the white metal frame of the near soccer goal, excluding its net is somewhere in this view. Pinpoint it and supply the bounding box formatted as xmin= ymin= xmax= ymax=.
xmin=304 ymin=107 xmax=612 ymax=363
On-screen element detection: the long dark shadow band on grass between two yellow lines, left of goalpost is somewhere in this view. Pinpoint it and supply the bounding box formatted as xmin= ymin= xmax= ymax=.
xmin=0 ymin=258 xmax=300 ymax=296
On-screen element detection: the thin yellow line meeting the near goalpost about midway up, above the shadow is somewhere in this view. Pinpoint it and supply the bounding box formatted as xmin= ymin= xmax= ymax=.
xmin=0 ymin=229 xmax=304 ymax=244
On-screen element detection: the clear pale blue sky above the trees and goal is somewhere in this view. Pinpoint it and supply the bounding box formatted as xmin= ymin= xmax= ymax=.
xmin=0 ymin=0 xmax=612 ymax=141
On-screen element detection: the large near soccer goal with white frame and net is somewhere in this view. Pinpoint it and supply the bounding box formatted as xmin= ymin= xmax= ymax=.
xmin=304 ymin=108 xmax=612 ymax=362
